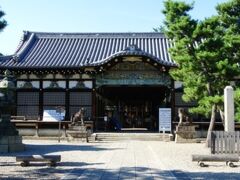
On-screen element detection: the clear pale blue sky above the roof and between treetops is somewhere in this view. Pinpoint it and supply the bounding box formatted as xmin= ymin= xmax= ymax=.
xmin=0 ymin=0 xmax=227 ymax=55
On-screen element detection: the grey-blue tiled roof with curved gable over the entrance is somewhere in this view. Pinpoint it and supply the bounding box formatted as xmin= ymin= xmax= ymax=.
xmin=0 ymin=31 xmax=176 ymax=68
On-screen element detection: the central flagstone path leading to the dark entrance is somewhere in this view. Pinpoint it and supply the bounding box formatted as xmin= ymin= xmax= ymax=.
xmin=62 ymin=141 xmax=174 ymax=179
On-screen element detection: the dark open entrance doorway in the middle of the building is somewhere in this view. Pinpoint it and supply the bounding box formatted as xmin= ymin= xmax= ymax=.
xmin=96 ymin=86 xmax=170 ymax=131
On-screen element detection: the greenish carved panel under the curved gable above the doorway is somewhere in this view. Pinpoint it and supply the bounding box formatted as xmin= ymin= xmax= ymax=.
xmin=96 ymin=62 xmax=171 ymax=87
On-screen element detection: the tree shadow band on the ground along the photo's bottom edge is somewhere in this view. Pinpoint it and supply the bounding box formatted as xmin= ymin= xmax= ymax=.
xmin=0 ymin=167 xmax=240 ymax=180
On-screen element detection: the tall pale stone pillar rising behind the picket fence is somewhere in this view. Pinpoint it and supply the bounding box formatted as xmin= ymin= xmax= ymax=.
xmin=224 ymin=86 xmax=235 ymax=132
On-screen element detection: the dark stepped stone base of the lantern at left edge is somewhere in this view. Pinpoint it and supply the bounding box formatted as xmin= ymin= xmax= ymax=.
xmin=0 ymin=115 xmax=25 ymax=153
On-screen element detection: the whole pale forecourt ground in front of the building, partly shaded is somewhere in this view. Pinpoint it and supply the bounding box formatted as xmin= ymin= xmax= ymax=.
xmin=0 ymin=140 xmax=240 ymax=180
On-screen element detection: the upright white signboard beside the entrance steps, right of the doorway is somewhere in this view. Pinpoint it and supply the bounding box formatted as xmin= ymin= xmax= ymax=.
xmin=159 ymin=108 xmax=172 ymax=132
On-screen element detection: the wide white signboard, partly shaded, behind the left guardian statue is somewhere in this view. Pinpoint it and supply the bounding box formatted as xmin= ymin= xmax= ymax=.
xmin=43 ymin=109 xmax=65 ymax=121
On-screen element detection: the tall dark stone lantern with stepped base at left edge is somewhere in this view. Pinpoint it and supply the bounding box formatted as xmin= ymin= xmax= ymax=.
xmin=0 ymin=70 xmax=24 ymax=153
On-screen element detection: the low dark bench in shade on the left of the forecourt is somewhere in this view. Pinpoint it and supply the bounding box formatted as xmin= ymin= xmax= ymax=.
xmin=16 ymin=155 xmax=61 ymax=167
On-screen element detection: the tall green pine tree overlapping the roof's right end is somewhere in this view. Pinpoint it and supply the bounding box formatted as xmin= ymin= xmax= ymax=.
xmin=163 ymin=0 xmax=240 ymax=146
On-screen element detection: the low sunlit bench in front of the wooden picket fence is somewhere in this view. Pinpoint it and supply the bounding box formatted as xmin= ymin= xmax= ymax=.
xmin=192 ymin=154 xmax=239 ymax=167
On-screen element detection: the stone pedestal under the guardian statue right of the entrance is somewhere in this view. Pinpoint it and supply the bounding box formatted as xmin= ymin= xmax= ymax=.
xmin=175 ymin=124 xmax=196 ymax=143
